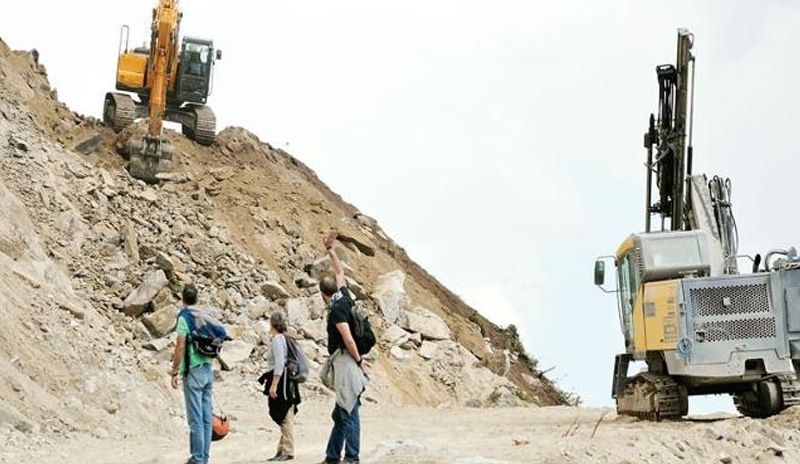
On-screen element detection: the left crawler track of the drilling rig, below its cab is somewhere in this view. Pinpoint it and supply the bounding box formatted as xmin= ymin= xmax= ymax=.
xmin=617 ymin=372 xmax=689 ymax=421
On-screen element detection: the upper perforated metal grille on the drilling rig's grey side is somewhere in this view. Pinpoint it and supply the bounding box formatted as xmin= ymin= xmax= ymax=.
xmin=689 ymin=283 xmax=770 ymax=317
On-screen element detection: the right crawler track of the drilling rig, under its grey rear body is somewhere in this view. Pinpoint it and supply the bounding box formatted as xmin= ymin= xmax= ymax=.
xmin=731 ymin=374 xmax=800 ymax=419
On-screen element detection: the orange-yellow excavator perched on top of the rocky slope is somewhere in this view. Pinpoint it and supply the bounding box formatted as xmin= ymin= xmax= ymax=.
xmin=103 ymin=0 xmax=222 ymax=182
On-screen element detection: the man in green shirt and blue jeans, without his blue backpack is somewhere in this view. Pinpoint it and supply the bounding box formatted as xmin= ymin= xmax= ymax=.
xmin=171 ymin=284 xmax=214 ymax=464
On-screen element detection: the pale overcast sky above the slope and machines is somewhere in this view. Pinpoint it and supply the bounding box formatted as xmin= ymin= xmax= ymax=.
xmin=0 ymin=0 xmax=800 ymax=412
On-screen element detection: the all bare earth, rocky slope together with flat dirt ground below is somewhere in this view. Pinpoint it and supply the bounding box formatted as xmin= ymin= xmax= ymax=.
xmin=0 ymin=41 xmax=800 ymax=464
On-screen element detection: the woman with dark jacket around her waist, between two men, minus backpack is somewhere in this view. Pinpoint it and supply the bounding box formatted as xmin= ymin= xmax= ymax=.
xmin=260 ymin=311 xmax=300 ymax=461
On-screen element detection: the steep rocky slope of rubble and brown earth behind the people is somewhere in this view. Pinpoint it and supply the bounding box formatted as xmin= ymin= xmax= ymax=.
xmin=0 ymin=36 xmax=567 ymax=450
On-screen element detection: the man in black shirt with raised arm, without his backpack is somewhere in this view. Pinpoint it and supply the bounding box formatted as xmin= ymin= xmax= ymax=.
xmin=319 ymin=231 xmax=369 ymax=464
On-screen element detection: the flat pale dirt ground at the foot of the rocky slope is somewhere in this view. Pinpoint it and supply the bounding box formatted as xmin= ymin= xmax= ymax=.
xmin=0 ymin=376 xmax=800 ymax=464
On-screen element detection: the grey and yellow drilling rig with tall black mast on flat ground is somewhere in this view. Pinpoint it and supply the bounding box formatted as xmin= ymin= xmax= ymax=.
xmin=594 ymin=29 xmax=800 ymax=420
